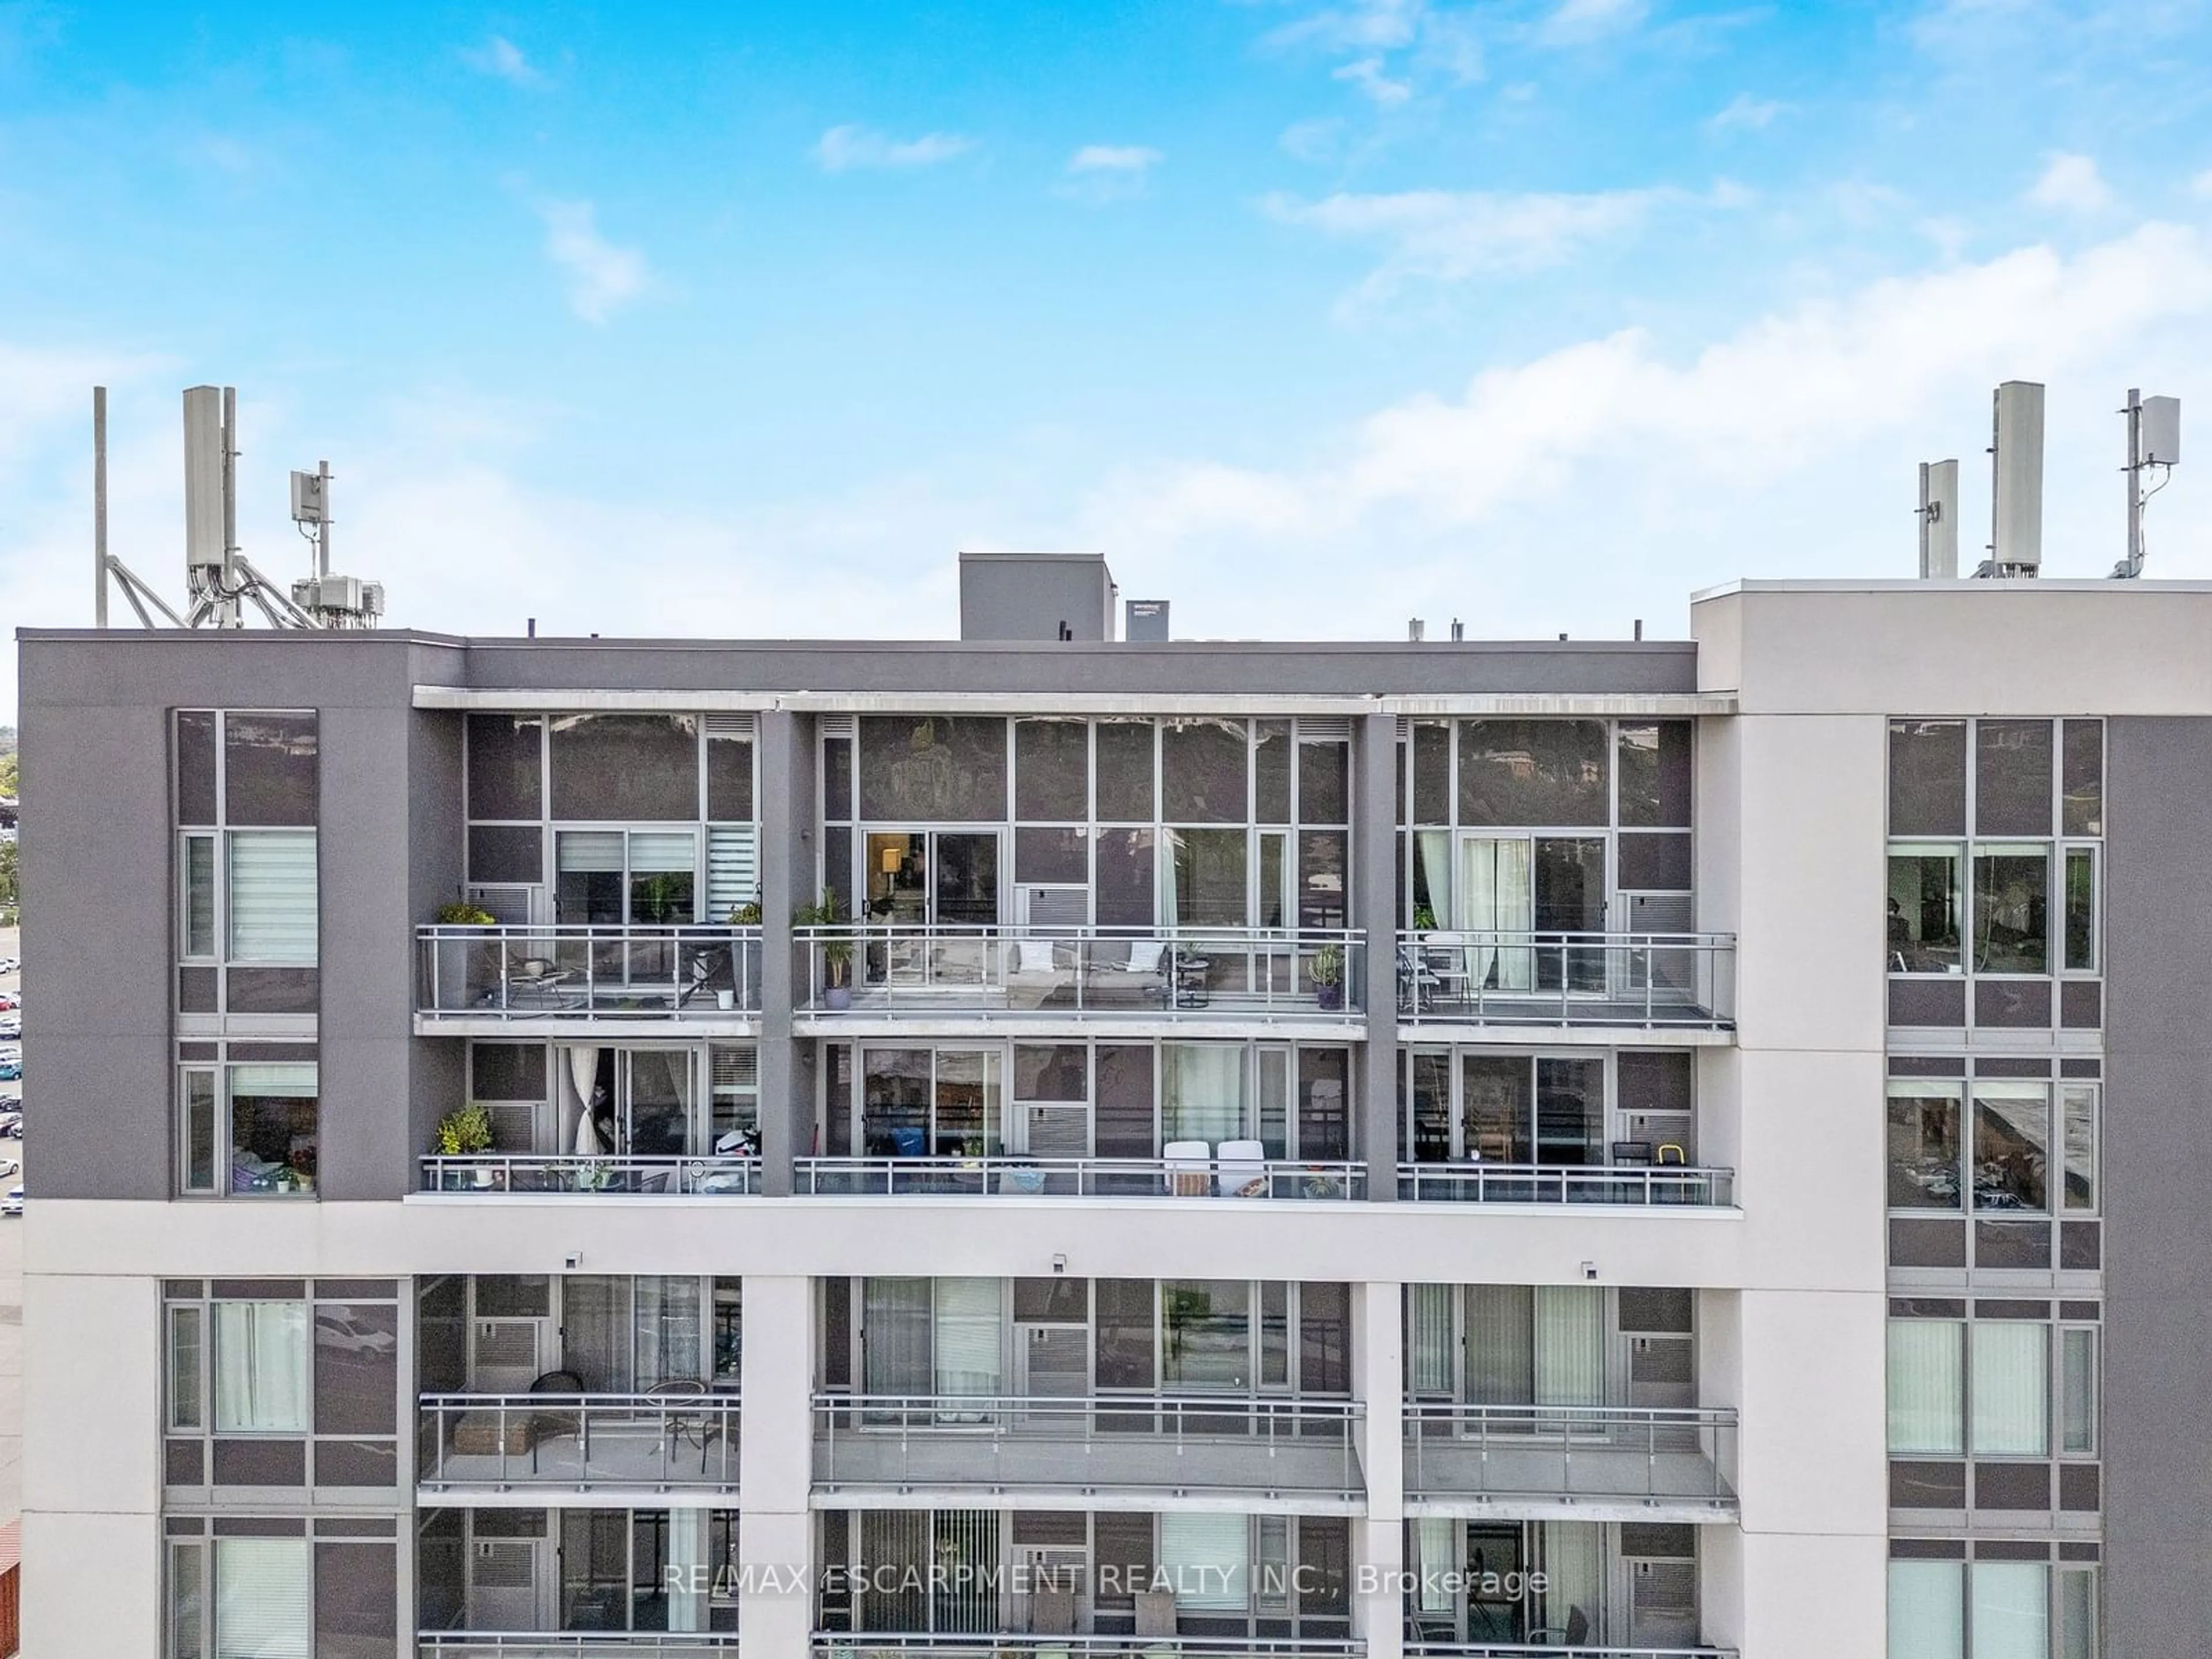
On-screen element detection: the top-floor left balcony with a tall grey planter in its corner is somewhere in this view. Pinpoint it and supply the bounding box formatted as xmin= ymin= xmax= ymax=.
xmin=416 ymin=925 xmax=761 ymax=1035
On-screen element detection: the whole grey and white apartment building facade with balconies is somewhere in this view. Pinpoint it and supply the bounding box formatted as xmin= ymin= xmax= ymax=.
xmin=22 ymin=560 xmax=2212 ymax=1659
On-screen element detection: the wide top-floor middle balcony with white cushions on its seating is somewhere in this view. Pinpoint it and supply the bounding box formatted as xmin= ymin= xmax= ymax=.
xmin=794 ymin=925 xmax=1367 ymax=1031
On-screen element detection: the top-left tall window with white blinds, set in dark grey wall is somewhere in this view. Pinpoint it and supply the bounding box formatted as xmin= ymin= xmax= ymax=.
xmin=173 ymin=708 xmax=321 ymax=1024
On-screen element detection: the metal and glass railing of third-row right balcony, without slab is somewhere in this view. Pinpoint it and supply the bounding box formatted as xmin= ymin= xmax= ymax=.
xmin=1404 ymin=1400 xmax=1736 ymax=1509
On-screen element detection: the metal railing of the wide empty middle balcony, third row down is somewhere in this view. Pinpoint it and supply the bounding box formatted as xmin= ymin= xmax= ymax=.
xmin=814 ymin=1393 xmax=1367 ymax=1498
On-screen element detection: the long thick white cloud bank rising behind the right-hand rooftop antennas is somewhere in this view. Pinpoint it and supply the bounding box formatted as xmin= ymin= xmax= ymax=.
xmin=1082 ymin=224 xmax=2212 ymax=619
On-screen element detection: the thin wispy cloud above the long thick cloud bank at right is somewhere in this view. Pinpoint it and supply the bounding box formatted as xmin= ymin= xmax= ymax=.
xmin=1263 ymin=186 xmax=1707 ymax=301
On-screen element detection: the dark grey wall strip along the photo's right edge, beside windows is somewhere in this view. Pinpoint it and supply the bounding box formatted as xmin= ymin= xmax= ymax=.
xmin=2104 ymin=719 xmax=2212 ymax=1659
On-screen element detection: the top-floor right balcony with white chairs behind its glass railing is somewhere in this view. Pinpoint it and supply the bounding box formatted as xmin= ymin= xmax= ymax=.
xmin=1398 ymin=931 xmax=1736 ymax=1033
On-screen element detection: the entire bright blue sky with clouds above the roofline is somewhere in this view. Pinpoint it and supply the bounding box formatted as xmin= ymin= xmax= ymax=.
xmin=0 ymin=0 xmax=2212 ymax=703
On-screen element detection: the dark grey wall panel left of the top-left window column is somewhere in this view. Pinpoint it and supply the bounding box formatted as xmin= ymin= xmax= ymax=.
xmin=18 ymin=699 xmax=175 ymax=1199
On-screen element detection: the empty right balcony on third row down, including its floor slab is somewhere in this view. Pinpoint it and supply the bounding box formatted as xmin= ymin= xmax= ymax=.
xmin=1404 ymin=1403 xmax=1736 ymax=1522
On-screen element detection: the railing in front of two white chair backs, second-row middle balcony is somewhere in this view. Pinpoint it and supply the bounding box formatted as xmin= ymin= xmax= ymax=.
xmin=792 ymin=1153 xmax=1367 ymax=1201
